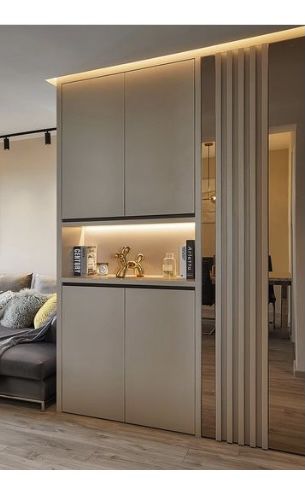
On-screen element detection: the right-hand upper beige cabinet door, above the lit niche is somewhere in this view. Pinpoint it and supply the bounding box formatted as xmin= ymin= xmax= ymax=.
xmin=125 ymin=60 xmax=194 ymax=215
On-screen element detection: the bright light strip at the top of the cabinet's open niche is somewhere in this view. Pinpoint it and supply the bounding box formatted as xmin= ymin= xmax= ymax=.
xmin=84 ymin=222 xmax=195 ymax=233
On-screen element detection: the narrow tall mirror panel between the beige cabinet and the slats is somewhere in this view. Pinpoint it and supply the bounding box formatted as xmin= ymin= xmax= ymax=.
xmin=201 ymin=57 xmax=216 ymax=439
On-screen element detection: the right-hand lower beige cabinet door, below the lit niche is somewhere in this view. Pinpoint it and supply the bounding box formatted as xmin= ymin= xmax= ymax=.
xmin=125 ymin=288 xmax=195 ymax=434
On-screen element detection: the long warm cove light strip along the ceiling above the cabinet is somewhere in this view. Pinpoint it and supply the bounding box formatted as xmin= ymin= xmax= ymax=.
xmin=47 ymin=26 xmax=305 ymax=86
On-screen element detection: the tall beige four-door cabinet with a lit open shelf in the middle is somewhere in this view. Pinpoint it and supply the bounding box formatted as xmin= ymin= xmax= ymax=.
xmin=58 ymin=59 xmax=200 ymax=434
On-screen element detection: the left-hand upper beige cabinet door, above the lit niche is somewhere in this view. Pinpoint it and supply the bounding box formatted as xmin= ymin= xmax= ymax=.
xmin=62 ymin=74 xmax=124 ymax=219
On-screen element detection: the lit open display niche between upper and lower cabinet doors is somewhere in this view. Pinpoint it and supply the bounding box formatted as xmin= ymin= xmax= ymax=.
xmin=62 ymin=219 xmax=195 ymax=286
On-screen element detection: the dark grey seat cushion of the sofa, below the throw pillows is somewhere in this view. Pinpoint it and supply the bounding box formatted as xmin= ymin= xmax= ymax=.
xmin=0 ymin=342 xmax=56 ymax=381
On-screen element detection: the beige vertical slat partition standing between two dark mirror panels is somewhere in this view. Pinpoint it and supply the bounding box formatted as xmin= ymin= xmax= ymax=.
xmin=215 ymin=45 xmax=268 ymax=448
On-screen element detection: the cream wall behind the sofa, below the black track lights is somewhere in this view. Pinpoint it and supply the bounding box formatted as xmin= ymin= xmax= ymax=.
xmin=0 ymin=137 xmax=56 ymax=276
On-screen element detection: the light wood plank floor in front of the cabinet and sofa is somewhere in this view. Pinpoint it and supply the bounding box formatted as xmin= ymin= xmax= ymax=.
xmin=0 ymin=400 xmax=305 ymax=470
